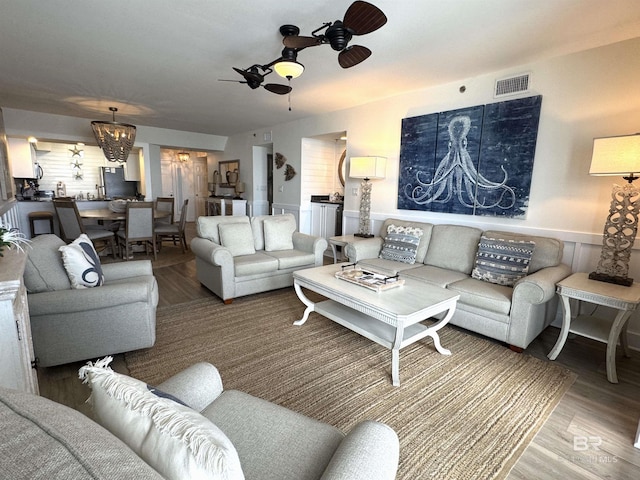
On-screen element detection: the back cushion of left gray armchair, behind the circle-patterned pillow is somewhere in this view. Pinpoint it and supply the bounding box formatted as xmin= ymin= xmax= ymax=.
xmin=24 ymin=234 xmax=71 ymax=293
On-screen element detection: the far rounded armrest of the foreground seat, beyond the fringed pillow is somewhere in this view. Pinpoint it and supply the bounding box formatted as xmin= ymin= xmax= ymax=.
xmin=158 ymin=362 xmax=222 ymax=412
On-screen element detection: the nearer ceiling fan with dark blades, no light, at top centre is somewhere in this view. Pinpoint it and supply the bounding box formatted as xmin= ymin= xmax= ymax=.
xmin=280 ymin=0 xmax=387 ymax=68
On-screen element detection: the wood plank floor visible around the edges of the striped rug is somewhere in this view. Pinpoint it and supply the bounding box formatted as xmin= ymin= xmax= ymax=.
xmin=38 ymin=225 xmax=640 ymax=480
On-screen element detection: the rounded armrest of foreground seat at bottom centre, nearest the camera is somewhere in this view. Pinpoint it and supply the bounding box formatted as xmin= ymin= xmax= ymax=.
xmin=321 ymin=420 xmax=400 ymax=480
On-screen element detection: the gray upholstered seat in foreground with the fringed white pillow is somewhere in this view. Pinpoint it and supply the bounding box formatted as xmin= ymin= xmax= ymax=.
xmin=0 ymin=363 xmax=400 ymax=480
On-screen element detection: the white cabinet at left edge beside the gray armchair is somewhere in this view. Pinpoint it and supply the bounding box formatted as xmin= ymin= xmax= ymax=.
xmin=0 ymin=249 xmax=38 ymax=394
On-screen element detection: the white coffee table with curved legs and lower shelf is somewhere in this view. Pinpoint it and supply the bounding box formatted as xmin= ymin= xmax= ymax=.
xmin=293 ymin=264 xmax=460 ymax=386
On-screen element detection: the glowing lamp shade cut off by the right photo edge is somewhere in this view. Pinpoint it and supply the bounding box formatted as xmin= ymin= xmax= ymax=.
xmin=589 ymin=134 xmax=640 ymax=176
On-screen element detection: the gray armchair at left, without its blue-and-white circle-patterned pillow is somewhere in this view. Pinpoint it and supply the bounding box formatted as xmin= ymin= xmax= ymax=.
xmin=24 ymin=235 xmax=158 ymax=367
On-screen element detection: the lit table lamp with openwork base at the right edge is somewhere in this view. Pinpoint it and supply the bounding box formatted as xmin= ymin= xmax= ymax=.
xmin=589 ymin=133 xmax=640 ymax=287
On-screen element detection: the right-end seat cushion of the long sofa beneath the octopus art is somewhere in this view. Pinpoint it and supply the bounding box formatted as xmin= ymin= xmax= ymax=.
xmin=447 ymin=277 xmax=513 ymax=315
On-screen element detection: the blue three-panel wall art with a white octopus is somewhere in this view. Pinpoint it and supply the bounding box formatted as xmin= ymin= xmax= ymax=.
xmin=398 ymin=96 xmax=542 ymax=218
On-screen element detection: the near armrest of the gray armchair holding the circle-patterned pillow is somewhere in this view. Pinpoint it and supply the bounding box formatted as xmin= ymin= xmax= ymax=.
xmin=27 ymin=280 xmax=157 ymax=316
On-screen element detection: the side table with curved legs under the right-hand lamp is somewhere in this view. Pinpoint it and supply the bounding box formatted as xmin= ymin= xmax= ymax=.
xmin=547 ymin=273 xmax=640 ymax=383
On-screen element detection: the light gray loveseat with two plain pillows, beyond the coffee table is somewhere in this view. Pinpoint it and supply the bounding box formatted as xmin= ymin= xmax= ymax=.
xmin=190 ymin=214 xmax=327 ymax=304
